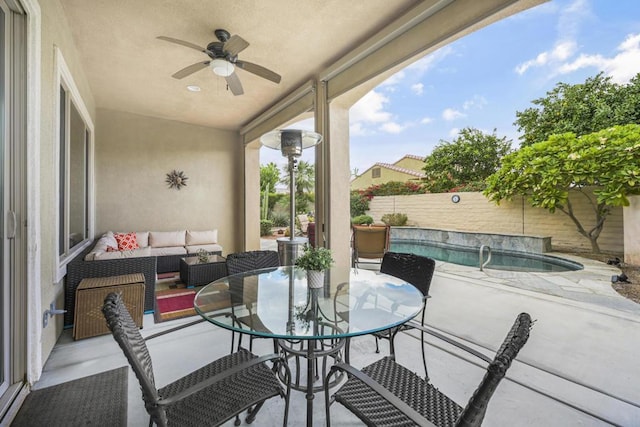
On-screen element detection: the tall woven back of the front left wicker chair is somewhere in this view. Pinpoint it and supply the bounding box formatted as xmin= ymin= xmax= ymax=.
xmin=102 ymin=292 xmax=166 ymax=425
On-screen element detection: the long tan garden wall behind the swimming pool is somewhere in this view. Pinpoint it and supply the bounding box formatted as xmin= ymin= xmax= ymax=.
xmin=368 ymin=193 xmax=624 ymax=253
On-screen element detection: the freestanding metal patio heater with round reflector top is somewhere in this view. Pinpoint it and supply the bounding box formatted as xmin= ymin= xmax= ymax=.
xmin=260 ymin=129 xmax=322 ymax=265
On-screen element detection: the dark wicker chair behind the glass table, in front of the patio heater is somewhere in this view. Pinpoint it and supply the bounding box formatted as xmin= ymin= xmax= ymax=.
xmin=227 ymin=250 xmax=280 ymax=352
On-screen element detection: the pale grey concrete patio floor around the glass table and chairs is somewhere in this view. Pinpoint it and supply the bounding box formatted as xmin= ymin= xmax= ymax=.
xmin=35 ymin=246 xmax=640 ymax=426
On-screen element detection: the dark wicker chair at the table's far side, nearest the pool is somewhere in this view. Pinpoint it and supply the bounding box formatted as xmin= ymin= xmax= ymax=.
xmin=374 ymin=252 xmax=436 ymax=379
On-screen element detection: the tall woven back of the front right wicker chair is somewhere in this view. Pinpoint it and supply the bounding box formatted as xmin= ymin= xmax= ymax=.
xmin=456 ymin=313 xmax=532 ymax=427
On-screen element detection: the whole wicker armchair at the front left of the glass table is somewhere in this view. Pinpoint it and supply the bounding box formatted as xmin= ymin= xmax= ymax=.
xmin=102 ymin=293 xmax=291 ymax=426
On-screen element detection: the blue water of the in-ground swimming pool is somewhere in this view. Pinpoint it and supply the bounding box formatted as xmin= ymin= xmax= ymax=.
xmin=390 ymin=240 xmax=584 ymax=272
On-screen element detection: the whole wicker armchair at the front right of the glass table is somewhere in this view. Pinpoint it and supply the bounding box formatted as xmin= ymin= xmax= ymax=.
xmin=325 ymin=313 xmax=532 ymax=427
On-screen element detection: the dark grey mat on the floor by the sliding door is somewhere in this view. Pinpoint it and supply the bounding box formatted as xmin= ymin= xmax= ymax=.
xmin=11 ymin=366 xmax=129 ymax=427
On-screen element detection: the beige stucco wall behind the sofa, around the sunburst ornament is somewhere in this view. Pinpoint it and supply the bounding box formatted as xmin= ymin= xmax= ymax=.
xmin=95 ymin=109 xmax=244 ymax=254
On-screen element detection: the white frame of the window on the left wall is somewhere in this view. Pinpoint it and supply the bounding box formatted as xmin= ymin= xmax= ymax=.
xmin=53 ymin=46 xmax=95 ymax=283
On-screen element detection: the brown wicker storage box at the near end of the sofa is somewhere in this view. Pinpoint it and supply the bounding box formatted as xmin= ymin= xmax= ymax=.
xmin=73 ymin=273 xmax=144 ymax=340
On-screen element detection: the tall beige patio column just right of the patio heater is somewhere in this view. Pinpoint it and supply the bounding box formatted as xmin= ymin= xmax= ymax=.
xmin=315 ymin=82 xmax=351 ymax=267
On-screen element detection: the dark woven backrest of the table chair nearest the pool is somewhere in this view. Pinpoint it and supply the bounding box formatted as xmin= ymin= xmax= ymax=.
xmin=380 ymin=252 xmax=436 ymax=296
